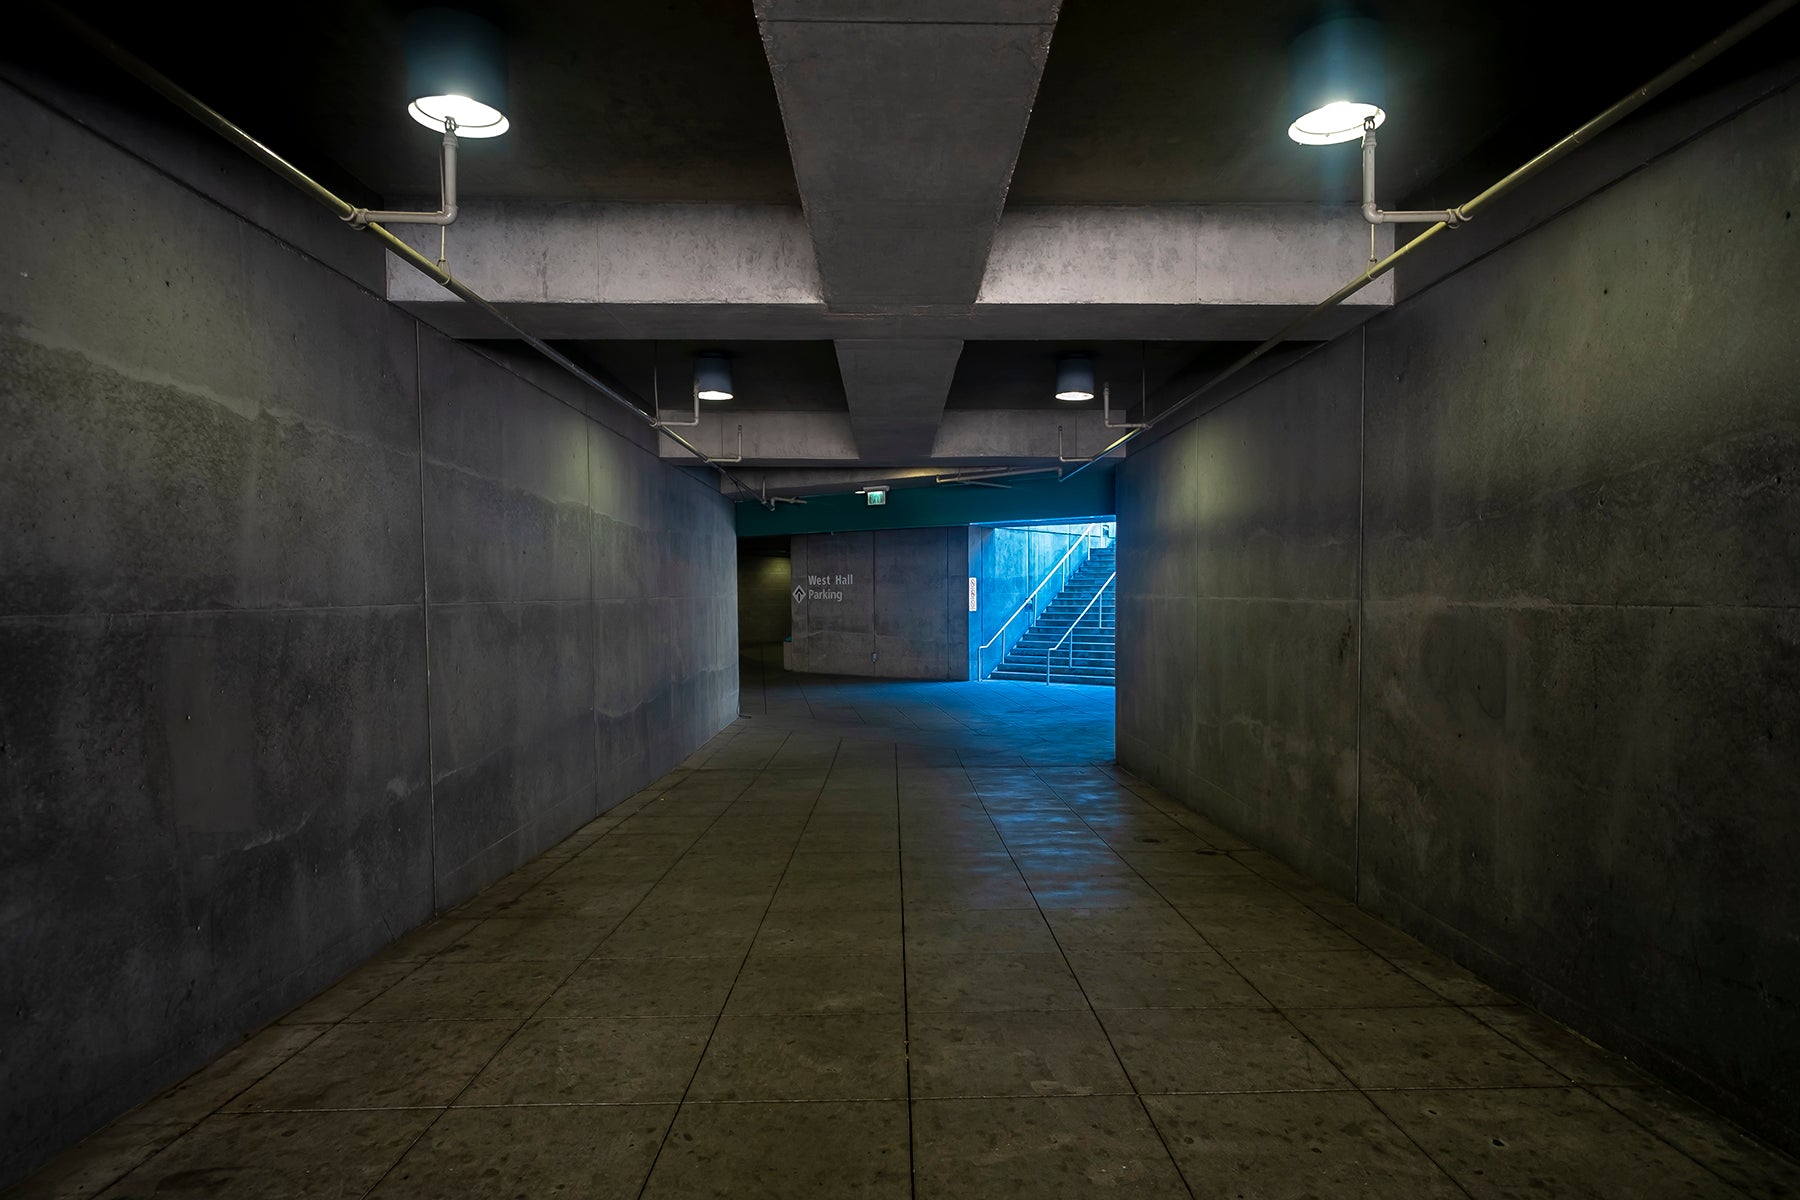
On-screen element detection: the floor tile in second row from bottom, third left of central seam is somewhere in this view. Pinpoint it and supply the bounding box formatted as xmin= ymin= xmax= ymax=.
xmin=227 ymin=1020 xmax=518 ymax=1112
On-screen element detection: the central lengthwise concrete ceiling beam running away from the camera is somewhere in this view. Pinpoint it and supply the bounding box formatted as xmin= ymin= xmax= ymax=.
xmin=756 ymin=0 xmax=1058 ymax=459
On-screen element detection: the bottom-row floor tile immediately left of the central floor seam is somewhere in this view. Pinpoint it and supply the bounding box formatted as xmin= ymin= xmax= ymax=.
xmin=644 ymin=1101 xmax=911 ymax=1200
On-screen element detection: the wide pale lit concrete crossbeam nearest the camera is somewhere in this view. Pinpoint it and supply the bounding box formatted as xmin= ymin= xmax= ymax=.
xmin=387 ymin=201 xmax=1393 ymax=342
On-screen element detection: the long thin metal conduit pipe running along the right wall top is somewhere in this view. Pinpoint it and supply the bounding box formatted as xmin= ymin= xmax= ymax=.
xmin=1062 ymin=0 xmax=1800 ymax=480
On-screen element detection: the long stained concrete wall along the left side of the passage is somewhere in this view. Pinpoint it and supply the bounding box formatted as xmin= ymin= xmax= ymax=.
xmin=0 ymin=83 xmax=736 ymax=1184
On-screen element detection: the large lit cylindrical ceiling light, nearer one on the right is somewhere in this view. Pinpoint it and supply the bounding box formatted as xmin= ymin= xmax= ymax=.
xmin=1287 ymin=16 xmax=1388 ymax=146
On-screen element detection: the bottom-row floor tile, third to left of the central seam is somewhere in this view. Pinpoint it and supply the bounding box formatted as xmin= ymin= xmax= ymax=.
xmin=101 ymin=1108 xmax=437 ymax=1200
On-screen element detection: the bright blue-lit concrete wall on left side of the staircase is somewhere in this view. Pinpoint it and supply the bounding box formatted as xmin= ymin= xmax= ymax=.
xmin=968 ymin=516 xmax=1114 ymax=678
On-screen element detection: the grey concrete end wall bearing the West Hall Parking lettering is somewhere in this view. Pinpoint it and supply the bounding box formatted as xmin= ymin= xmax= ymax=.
xmin=785 ymin=527 xmax=968 ymax=680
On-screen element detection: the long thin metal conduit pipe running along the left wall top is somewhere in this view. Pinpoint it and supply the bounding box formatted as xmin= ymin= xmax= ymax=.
xmin=45 ymin=4 xmax=774 ymax=511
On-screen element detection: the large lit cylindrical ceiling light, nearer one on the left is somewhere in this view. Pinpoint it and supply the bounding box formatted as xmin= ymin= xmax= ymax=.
xmin=405 ymin=9 xmax=508 ymax=137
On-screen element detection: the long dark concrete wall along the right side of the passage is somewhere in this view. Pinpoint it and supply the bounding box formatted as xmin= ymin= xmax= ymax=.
xmin=1118 ymin=82 xmax=1800 ymax=1146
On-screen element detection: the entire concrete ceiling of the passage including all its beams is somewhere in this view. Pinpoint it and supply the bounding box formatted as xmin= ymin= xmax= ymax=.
xmin=52 ymin=0 xmax=1775 ymax=488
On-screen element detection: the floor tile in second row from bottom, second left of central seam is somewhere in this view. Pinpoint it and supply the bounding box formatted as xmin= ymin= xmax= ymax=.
xmin=455 ymin=1016 xmax=713 ymax=1105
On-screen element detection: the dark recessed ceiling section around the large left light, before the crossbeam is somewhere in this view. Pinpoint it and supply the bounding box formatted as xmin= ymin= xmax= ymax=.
xmin=70 ymin=0 xmax=799 ymax=205
